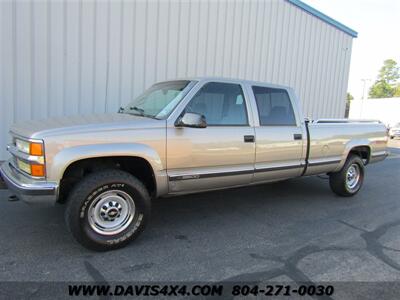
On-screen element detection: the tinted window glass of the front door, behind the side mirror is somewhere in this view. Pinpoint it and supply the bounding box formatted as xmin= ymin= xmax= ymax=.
xmin=186 ymin=82 xmax=248 ymax=125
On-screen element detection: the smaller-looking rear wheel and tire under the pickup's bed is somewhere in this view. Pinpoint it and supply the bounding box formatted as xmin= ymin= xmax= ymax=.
xmin=329 ymin=155 xmax=364 ymax=197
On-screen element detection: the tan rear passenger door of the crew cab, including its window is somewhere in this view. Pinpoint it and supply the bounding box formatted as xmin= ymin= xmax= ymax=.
xmin=250 ymin=85 xmax=306 ymax=182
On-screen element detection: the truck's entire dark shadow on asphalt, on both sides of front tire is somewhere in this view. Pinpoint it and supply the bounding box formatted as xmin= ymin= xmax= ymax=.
xmin=0 ymin=178 xmax=344 ymax=254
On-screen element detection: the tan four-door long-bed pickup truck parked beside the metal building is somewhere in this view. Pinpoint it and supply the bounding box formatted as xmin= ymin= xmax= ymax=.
xmin=0 ymin=78 xmax=388 ymax=251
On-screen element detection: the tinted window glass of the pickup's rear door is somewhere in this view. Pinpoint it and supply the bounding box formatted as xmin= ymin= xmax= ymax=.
xmin=253 ymin=86 xmax=296 ymax=125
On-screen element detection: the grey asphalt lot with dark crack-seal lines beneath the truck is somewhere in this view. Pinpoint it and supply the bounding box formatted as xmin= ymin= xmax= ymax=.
xmin=0 ymin=141 xmax=400 ymax=290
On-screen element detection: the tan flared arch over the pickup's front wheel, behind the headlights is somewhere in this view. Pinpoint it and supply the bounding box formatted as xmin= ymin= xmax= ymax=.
xmin=47 ymin=143 xmax=168 ymax=194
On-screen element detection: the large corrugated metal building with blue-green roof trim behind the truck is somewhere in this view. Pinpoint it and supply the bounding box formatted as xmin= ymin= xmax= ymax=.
xmin=0 ymin=0 xmax=357 ymax=159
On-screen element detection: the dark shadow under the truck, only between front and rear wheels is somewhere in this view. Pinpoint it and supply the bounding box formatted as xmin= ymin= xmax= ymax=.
xmin=153 ymin=178 xmax=334 ymax=221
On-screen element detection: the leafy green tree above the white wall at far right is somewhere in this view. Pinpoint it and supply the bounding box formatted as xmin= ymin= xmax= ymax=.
xmin=369 ymin=59 xmax=400 ymax=98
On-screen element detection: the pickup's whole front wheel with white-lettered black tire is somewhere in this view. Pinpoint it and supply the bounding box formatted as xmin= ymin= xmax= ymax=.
xmin=65 ymin=170 xmax=150 ymax=251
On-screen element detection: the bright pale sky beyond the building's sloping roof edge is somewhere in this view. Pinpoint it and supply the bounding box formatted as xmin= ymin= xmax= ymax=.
xmin=303 ymin=0 xmax=400 ymax=99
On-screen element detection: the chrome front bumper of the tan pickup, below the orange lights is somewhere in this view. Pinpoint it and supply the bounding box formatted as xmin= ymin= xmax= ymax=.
xmin=0 ymin=161 xmax=58 ymax=205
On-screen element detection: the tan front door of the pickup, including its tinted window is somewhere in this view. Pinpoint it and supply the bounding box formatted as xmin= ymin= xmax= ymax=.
xmin=167 ymin=82 xmax=255 ymax=193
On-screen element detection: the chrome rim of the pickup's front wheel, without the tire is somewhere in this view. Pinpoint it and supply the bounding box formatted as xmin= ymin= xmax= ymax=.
xmin=88 ymin=190 xmax=136 ymax=235
